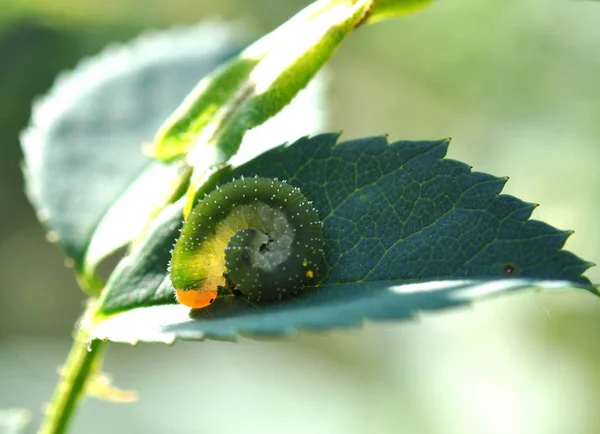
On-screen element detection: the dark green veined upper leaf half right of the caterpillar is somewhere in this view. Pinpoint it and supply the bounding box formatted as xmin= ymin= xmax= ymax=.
xmin=233 ymin=135 xmax=591 ymax=284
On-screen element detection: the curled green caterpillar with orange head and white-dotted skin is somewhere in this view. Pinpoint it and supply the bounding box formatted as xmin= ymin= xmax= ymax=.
xmin=169 ymin=177 xmax=324 ymax=309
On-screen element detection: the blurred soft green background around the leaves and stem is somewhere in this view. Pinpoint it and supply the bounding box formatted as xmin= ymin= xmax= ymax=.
xmin=0 ymin=0 xmax=600 ymax=434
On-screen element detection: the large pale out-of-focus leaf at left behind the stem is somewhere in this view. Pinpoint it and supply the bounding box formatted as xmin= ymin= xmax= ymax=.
xmin=22 ymin=22 xmax=246 ymax=292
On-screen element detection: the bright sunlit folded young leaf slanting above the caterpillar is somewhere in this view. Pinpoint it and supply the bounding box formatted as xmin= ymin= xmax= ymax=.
xmin=150 ymin=0 xmax=370 ymax=169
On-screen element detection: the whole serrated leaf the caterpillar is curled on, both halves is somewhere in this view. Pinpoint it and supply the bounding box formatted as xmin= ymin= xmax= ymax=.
xmin=96 ymin=134 xmax=590 ymax=341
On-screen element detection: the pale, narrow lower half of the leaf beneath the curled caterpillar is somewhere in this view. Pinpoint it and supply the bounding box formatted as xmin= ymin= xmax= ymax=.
xmin=92 ymin=279 xmax=584 ymax=345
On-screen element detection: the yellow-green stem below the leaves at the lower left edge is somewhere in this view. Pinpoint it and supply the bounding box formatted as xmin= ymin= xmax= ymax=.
xmin=38 ymin=316 xmax=105 ymax=434
